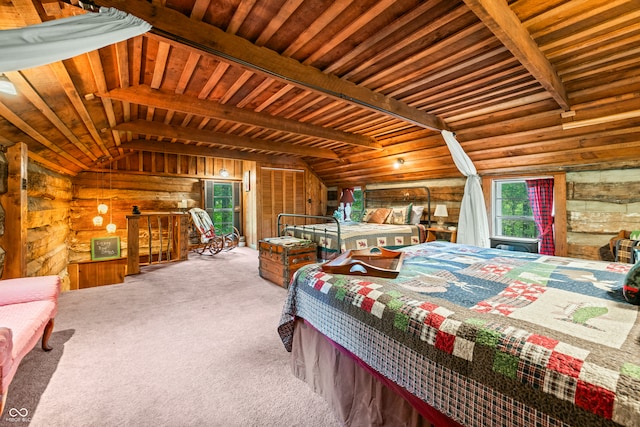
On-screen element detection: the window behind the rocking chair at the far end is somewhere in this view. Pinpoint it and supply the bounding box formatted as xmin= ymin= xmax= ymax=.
xmin=205 ymin=181 xmax=242 ymax=234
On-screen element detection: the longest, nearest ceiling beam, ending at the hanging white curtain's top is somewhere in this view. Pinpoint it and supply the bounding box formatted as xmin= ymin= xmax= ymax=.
xmin=99 ymin=0 xmax=448 ymax=131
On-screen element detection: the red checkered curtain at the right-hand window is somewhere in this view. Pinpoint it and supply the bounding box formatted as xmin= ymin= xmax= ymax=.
xmin=526 ymin=178 xmax=556 ymax=255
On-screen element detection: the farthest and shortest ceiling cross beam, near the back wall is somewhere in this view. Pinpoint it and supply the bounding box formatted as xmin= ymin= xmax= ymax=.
xmin=122 ymin=139 xmax=306 ymax=167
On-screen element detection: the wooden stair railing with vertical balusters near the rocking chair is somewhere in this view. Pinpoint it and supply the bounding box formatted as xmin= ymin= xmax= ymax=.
xmin=127 ymin=212 xmax=189 ymax=275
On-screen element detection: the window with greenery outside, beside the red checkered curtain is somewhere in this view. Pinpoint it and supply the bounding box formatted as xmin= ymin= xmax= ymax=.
xmin=492 ymin=179 xmax=538 ymax=239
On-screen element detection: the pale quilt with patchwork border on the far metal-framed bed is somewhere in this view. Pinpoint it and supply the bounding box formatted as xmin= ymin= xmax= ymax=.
xmin=284 ymin=222 xmax=426 ymax=253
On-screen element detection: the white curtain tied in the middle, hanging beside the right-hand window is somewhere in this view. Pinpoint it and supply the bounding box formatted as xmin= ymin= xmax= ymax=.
xmin=441 ymin=130 xmax=489 ymax=248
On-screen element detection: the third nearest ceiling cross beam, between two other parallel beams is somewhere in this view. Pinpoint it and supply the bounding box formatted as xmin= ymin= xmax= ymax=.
xmin=113 ymin=120 xmax=339 ymax=159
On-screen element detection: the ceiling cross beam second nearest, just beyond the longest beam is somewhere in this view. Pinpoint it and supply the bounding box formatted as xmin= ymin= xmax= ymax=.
xmin=98 ymin=85 xmax=382 ymax=149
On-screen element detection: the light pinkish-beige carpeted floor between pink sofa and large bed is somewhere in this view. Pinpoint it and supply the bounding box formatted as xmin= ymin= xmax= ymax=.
xmin=0 ymin=247 xmax=338 ymax=427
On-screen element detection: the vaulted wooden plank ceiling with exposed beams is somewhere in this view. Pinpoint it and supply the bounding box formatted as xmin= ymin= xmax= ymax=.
xmin=0 ymin=0 xmax=640 ymax=185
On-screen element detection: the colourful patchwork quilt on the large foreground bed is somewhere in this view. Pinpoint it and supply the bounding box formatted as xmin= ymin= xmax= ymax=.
xmin=278 ymin=242 xmax=640 ymax=426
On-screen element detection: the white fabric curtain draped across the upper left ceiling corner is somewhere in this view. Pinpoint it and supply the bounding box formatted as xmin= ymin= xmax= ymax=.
xmin=0 ymin=7 xmax=151 ymax=73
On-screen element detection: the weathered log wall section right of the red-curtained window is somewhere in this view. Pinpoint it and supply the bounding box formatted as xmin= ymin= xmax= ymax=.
xmin=567 ymin=169 xmax=640 ymax=259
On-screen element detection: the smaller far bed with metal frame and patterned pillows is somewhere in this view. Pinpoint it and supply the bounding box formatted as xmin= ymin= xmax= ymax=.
xmin=278 ymin=187 xmax=431 ymax=260
